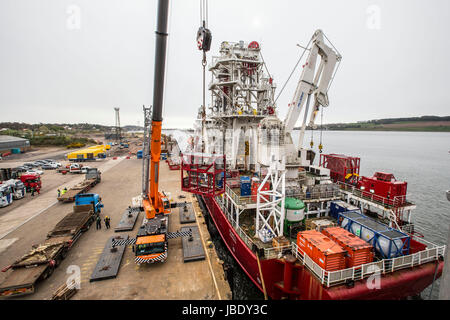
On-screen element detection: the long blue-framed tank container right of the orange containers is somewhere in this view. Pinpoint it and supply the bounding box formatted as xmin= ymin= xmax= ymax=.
xmin=338 ymin=211 xmax=410 ymax=259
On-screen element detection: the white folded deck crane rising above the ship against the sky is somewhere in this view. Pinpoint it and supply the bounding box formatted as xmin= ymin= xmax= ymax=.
xmin=284 ymin=30 xmax=342 ymax=164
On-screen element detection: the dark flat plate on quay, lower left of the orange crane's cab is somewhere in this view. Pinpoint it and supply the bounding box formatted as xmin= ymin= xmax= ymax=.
xmin=89 ymin=235 xmax=128 ymax=282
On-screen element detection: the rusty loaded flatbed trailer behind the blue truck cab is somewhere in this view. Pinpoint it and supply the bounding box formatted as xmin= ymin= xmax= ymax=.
xmin=0 ymin=205 xmax=98 ymax=298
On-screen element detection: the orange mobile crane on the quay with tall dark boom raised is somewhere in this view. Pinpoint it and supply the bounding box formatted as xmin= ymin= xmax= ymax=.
xmin=131 ymin=0 xmax=192 ymax=264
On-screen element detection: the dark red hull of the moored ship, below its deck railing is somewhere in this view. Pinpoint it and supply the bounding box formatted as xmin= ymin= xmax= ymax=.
xmin=203 ymin=197 xmax=444 ymax=300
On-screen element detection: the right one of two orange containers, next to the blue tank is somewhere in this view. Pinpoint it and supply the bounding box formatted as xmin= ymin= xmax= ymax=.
xmin=322 ymin=227 xmax=373 ymax=268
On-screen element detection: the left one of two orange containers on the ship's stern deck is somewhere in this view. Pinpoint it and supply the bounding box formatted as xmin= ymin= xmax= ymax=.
xmin=297 ymin=230 xmax=346 ymax=271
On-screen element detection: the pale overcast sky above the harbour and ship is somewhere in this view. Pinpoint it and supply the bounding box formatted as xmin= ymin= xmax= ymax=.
xmin=0 ymin=0 xmax=450 ymax=128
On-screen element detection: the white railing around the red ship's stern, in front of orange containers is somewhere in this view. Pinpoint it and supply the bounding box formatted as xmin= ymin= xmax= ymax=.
xmin=291 ymin=239 xmax=445 ymax=287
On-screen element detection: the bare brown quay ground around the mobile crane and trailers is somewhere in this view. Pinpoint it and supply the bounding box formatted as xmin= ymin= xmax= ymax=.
xmin=0 ymin=157 xmax=231 ymax=300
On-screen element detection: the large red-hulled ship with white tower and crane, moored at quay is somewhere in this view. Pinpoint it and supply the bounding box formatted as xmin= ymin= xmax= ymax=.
xmin=177 ymin=30 xmax=445 ymax=300
